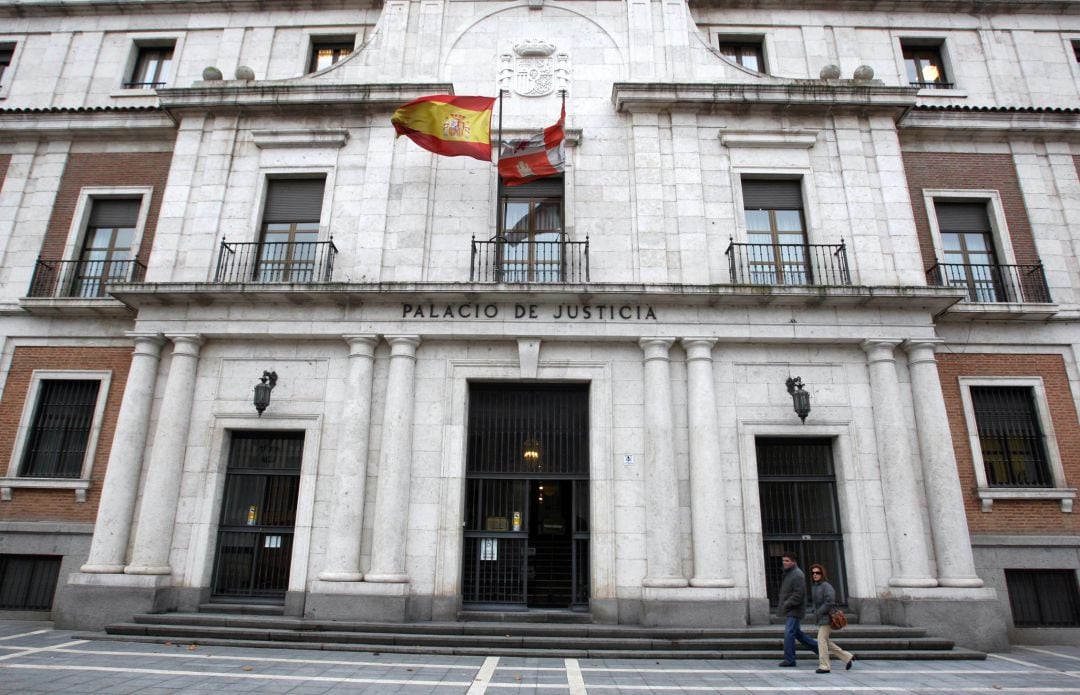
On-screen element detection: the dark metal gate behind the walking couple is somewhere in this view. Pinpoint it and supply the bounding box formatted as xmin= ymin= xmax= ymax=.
xmin=756 ymin=437 xmax=848 ymax=607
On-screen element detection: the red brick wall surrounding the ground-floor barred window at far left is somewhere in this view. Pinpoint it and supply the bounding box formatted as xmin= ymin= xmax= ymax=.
xmin=0 ymin=348 xmax=132 ymax=522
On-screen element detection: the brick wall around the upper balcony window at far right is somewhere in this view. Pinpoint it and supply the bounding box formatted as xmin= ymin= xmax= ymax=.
xmin=904 ymin=152 xmax=1039 ymax=269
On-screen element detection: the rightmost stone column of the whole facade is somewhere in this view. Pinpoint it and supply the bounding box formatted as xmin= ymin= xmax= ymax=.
xmin=904 ymin=340 xmax=983 ymax=587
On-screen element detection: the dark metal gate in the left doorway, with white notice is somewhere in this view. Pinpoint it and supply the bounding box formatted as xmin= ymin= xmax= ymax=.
xmin=213 ymin=432 xmax=303 ymax=602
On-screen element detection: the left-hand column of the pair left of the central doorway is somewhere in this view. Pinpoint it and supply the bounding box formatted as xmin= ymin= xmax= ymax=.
xmin=319 ymin=336 xmax=378 ymax=582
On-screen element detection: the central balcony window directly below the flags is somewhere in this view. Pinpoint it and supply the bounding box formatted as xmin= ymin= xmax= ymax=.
xmin=497 ymin=176 xmax=565 ymax=283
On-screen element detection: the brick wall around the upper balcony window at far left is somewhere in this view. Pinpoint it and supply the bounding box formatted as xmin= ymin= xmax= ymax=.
xmin=41 ymin=152 xmax=173 ymax=263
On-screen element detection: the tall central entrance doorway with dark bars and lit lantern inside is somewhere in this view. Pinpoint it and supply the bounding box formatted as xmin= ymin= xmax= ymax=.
xmin=461 ymin=384 xmax=589 ymax=610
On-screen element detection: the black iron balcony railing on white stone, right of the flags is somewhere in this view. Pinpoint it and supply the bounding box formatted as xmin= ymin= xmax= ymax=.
xmin=727 ymin=242 xmax=851 ymax=287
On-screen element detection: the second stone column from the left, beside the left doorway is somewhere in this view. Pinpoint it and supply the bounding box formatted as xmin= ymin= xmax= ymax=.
xmin=124 ymin=335 xmax=202 ymax=574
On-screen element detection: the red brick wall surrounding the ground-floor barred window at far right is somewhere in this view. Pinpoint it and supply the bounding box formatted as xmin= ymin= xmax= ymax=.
xmin=937 ymin=354 xmax=1080 ymax=535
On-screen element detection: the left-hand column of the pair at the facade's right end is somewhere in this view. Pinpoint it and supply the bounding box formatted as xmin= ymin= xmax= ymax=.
xmin=863 ymin=340 xmax=937 ymax=587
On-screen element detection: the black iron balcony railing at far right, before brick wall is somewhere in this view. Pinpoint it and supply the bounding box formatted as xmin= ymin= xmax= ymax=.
xmin=927 ymin=262 xmax=1051 ymax=304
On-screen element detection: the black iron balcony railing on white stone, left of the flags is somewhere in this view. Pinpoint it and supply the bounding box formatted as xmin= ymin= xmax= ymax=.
xmin=214 ymin=239 xmax=337 ymax=283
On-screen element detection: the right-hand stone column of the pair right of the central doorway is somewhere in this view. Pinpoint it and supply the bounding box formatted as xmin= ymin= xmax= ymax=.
xmin=683 ymin=338 xmax=734 ymax=587
